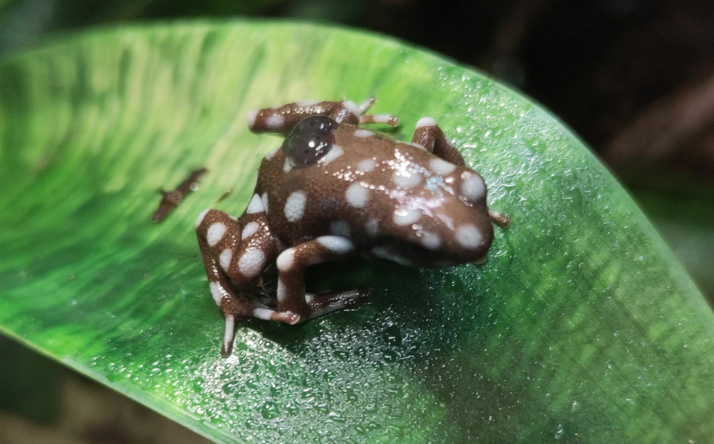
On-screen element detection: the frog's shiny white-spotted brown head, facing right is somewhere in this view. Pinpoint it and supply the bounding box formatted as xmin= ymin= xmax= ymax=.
xmin=364 ymin=160 xmax=493 ymax=267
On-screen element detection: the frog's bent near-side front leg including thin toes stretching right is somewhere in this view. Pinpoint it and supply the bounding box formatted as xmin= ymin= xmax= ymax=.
xmin=276 ymin=236 xmax=368 ymax=322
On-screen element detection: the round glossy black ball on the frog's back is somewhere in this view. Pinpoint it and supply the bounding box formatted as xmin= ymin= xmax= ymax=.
xmin=284 ymin=116 xmax=337 ymax=167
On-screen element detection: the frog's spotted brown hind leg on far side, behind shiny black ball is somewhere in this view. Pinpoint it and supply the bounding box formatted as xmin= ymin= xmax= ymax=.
xmin=248 ymin=99 xmax=399 ymax=134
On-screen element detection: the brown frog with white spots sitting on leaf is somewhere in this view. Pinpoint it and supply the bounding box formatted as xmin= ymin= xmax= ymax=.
xmin=196 ymin=99 xmax=509 ymax=355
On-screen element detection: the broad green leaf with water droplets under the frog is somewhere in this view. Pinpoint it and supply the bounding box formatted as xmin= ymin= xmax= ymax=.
xmin=0 ymin=22 xmax=714 ymax=442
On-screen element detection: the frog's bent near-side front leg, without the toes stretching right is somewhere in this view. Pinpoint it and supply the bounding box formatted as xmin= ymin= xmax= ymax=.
xmin=276 ymin=236 xmax=355 ymax=321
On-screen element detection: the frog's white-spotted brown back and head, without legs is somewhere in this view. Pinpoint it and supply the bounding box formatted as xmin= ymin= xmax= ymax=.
xmin=253 ymin=124 xmax=493 ymax=266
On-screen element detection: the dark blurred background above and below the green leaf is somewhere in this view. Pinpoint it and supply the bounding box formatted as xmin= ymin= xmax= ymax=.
xmin=0 ymin=0 xmax=714 ymax=443
